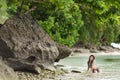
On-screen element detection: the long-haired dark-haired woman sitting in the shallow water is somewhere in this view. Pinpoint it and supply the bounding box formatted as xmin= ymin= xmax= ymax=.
xmin=87 ymin=55 xmax=100 ymax=73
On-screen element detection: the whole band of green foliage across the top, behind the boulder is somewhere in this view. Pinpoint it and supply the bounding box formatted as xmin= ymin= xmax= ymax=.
xmin=0 ymin=0 xmax=120 ymax=46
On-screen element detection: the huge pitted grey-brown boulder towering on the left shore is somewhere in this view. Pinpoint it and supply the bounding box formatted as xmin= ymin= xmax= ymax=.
xmin=0 ymin=14 xmax=59 ymax=72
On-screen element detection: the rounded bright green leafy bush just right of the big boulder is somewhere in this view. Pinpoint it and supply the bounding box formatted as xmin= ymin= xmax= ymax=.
xmin=36 ymin=0 xmax=83 ymax=46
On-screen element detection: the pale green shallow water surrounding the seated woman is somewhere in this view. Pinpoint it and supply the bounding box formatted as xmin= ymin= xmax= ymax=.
xmin=59 ymin=55 xmax=120 ymax=80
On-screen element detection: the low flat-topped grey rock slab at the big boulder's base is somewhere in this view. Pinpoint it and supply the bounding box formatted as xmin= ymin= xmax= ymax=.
xmin=7 ymin=58 xmax=41 ymax=74
